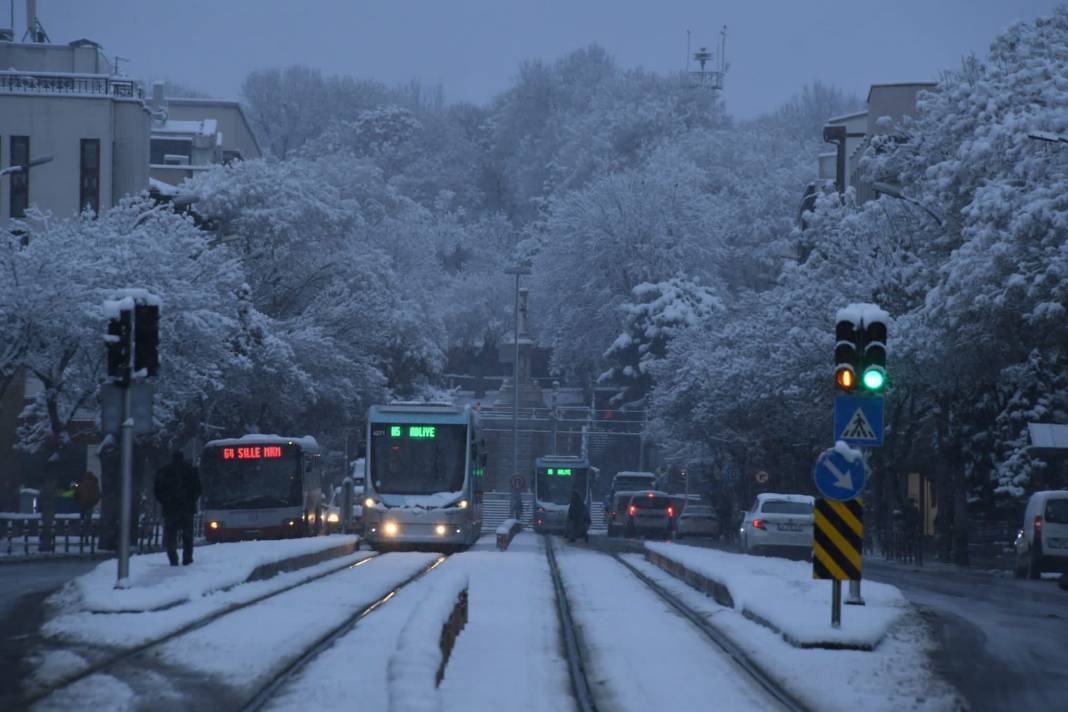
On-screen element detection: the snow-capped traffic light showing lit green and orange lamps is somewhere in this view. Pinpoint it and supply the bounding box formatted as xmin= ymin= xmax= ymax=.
xmin=834 ymin=304 xmax=890 ymax=395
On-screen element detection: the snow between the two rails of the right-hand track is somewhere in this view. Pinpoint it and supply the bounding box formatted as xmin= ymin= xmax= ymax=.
xmin=556 ymin=545 xmax=775 ymax=712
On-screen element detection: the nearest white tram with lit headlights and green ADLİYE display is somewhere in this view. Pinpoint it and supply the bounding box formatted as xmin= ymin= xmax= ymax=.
xmin=363 ymin=402 xmax=486 ymax=551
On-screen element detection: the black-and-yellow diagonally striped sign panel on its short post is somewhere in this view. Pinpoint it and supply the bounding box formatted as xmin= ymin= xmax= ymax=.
xmin=812 ymin=497 xmax=864 ymax=628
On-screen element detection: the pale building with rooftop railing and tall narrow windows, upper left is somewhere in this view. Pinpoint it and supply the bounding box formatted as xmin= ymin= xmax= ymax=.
xmin=0 ymin=39 xmax=152 ymax=226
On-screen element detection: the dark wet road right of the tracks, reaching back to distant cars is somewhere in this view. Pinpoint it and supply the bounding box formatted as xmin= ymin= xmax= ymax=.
xmin=591 ymin=537 xmax=1068 ymax=712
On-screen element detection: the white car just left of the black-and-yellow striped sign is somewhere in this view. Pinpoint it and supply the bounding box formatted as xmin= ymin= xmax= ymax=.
xmin=738 ymin=492 xmax=814 ymax=558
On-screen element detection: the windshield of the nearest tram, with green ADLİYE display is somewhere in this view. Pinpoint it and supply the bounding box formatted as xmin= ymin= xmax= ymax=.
xmin=371 ymin=423 xmax=467 ymax=494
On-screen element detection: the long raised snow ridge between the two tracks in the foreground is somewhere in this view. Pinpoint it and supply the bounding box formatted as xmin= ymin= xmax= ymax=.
xmin=387 ymin=570 xmax=468 ymax=712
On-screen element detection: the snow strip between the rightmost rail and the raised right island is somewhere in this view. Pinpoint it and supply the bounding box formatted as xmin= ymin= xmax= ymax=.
xmin=624 ymin=554 xmax=963 ymax=712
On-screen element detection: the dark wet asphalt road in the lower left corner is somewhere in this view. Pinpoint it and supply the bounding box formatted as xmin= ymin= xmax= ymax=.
xmin=0 ymin=559 xmax=100 ymax=710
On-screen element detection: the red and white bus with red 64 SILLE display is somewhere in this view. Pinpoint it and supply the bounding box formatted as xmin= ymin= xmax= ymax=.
xmin=200 ymin=434 xmax=325 ymax=543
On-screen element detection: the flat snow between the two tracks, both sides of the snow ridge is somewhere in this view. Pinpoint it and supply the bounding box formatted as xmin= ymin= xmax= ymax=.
xmin=271 ymin=534 xmax=572 ymax=712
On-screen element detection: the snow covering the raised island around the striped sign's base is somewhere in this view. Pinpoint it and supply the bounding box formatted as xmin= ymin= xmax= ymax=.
xmin=645 ymin=542 xmax=909 ymax=647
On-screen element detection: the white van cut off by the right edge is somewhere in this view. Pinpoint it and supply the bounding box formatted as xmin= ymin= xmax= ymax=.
xmin=1016 ymin=490 xmax=1068 ymax=579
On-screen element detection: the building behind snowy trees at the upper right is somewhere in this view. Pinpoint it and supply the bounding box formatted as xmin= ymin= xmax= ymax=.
xmin=799 ymin=81 xmax=938 ymax=220
